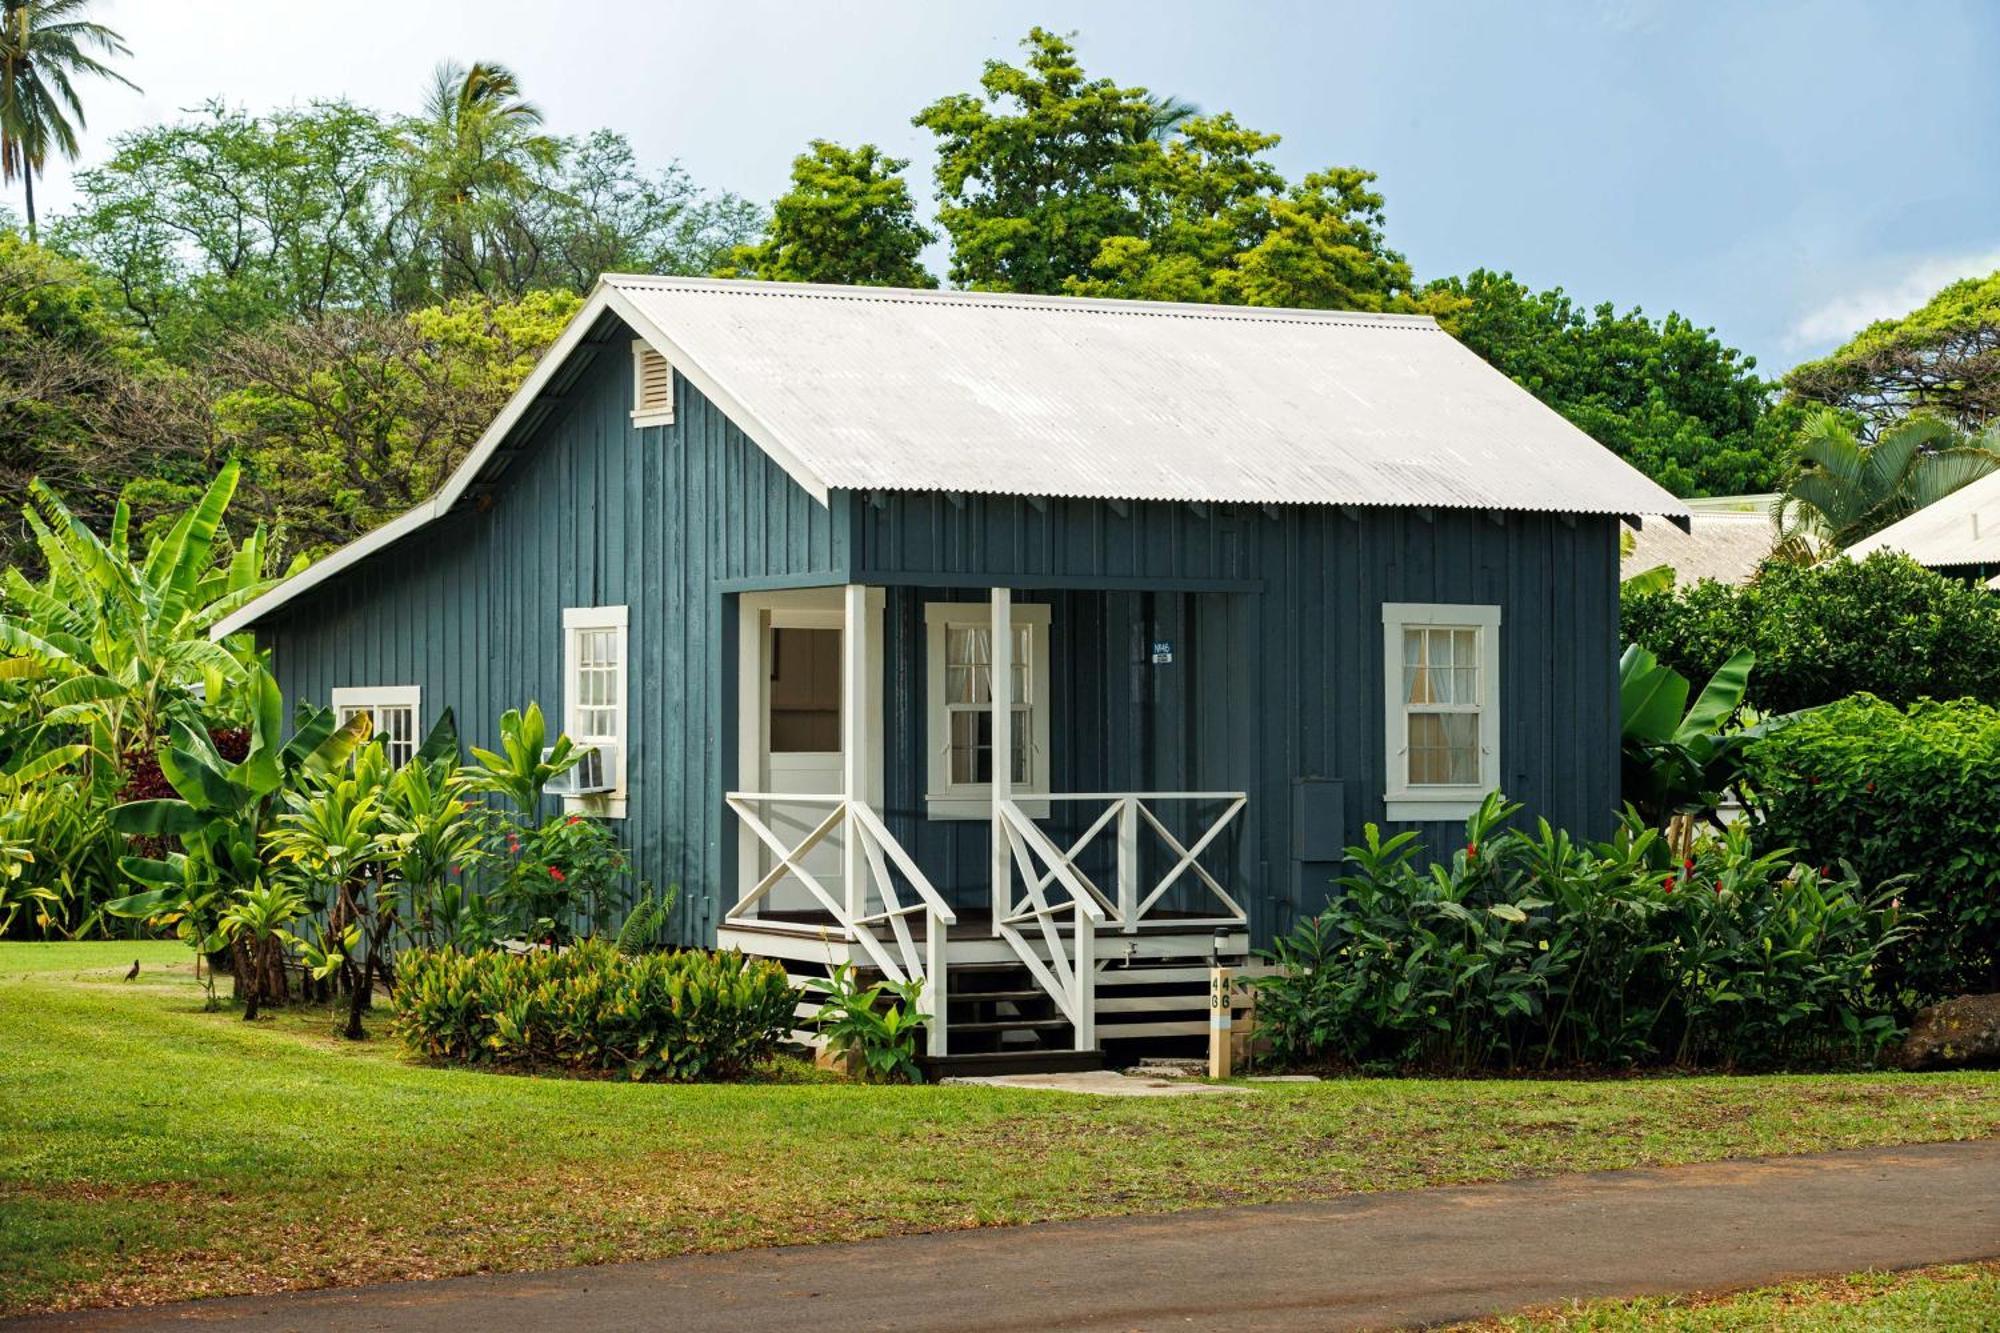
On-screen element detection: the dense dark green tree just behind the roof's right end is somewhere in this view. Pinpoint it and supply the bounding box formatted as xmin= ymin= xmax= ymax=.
xmin=1418 ymin=268 xmax=1798 ymax=496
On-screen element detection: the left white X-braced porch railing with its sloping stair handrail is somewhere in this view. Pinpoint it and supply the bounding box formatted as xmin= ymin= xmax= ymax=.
xmin=722 ymin=791 xmax=958 ymax=1055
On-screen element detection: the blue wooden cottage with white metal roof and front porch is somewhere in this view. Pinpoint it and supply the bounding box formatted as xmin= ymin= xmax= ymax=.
xmin=216 ymin=276 xmax=1686 ymax=1053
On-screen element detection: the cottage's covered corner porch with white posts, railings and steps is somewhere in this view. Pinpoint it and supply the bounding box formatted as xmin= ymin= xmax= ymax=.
xmin=718 ymin=584 xmax=1254 ymax=1057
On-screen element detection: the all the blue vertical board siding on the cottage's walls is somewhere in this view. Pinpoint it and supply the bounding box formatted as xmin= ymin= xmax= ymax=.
xmin=258 ymin=330 xmax=1618 ymax=941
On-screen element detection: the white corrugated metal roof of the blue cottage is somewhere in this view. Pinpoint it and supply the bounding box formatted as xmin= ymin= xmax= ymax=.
xmin=604 ymin=274 xmax=1686 ymax=516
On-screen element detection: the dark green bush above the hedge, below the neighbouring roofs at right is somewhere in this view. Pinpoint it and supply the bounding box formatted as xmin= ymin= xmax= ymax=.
xmin=1622 ymin=552 xmax=2000 ymax=713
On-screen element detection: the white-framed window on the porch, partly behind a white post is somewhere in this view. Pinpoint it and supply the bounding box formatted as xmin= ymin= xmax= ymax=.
xmin=924 ymin=602 xmax=1050 ymax=819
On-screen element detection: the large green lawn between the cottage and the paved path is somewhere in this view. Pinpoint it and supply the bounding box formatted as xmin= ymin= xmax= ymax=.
xmin=11 ymin=945 xmax=2000 ymax=1311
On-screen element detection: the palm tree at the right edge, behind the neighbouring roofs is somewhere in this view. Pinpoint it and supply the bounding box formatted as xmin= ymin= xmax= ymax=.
xmin=1776 ymin=410 xmax=2000 ymax=560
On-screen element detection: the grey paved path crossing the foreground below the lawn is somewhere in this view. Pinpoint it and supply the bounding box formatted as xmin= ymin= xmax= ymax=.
xmin=19 ymin=1141 xmax=2000 ymax=1333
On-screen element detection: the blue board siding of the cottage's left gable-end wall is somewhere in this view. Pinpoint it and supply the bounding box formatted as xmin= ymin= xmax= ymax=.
xmin=258 ymin=320 xmax=844 ymax=941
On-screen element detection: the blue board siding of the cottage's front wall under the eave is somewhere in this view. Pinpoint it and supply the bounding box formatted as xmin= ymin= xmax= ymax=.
xmin=854 ymin=494 xmax=1618 ymax=941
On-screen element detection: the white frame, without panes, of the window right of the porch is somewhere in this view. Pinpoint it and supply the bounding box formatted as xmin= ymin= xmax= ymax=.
xmin=1382 ymin=602 xmax=1502 ymax=823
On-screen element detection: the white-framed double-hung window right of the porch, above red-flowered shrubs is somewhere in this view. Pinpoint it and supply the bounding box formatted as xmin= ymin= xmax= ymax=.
xmin=1382 ymin=602 xmax=1500 ymax=821
